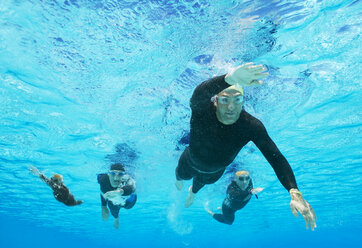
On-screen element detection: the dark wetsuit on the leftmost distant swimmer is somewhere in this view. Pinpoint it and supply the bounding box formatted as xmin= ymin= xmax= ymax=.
xmin=40 ymin=174 xmax=83 ymax=206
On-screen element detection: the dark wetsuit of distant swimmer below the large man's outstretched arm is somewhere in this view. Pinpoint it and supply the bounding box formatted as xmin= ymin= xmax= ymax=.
xmin=213 ymin=180 xmax=253 ymax=225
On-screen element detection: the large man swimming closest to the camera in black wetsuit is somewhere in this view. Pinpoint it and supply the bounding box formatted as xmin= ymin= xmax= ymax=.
xmin=176 ymin=63 xmax=316 ymax=230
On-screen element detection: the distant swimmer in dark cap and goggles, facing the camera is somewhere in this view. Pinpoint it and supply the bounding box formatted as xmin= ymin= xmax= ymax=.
xmin=97 ymin=163 xmax=137 ymax=229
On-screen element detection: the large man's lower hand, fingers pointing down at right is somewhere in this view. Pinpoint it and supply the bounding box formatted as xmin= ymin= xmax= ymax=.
xmin=289 ymin=189 xmax=317 ymax=231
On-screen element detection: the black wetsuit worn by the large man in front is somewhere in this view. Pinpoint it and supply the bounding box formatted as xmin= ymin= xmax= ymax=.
xmin=176 ymin=75 xmax=297 ymax=193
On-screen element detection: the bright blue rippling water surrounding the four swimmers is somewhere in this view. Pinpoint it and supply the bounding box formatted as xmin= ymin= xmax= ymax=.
xmin=0 ymin=0 xmax=362 ymax=248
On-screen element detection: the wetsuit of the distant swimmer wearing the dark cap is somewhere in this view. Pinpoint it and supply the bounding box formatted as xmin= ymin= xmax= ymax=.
xmin=97 ymin=174 xmax=137 ymax=218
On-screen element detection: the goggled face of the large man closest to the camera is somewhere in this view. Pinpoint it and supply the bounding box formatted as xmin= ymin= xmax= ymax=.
xmin=214 ymin=89 xmax=243 ymax=125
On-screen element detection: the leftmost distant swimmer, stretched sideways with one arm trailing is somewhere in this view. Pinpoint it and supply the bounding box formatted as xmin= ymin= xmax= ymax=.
xmin=30 ymin=166 xmax=83 ymax=206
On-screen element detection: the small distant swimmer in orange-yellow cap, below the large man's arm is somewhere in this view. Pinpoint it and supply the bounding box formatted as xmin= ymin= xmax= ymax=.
xmin=206 ymin=171 xmax=263 ymax=225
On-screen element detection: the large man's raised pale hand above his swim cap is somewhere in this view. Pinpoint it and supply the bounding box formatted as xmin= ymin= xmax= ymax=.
xmin=225 ymin=63 xmax=269 ymax=86
